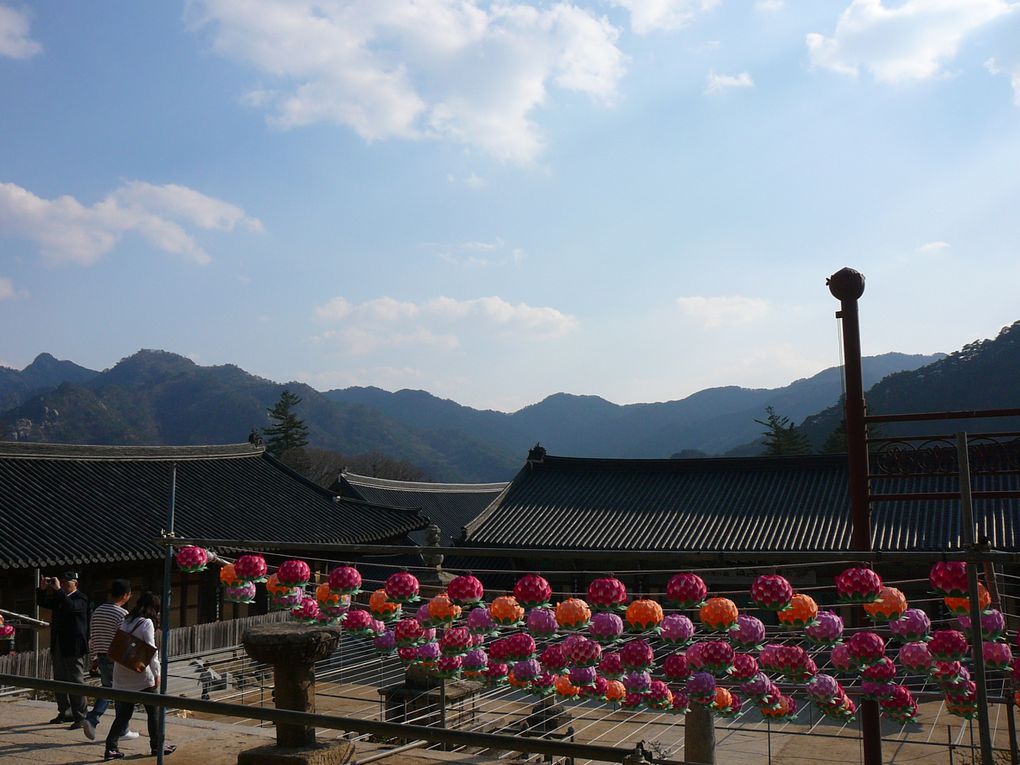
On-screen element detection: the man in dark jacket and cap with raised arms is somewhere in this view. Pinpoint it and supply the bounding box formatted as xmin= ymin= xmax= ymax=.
xmin=36 ymin=571 xmax=91 ymax=729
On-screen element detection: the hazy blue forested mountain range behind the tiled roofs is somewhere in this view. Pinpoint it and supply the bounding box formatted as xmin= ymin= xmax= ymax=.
xmin=0 ymin=322 xmax=1020 ymax=481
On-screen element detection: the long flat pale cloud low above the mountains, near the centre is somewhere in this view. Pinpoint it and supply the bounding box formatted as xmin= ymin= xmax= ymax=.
xmin=312 ymin=296 xmax=577 ymax=354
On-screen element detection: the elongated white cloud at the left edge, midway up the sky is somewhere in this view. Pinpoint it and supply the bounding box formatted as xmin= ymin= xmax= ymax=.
xmin=0 ymin=181 xmax=262 ymax=265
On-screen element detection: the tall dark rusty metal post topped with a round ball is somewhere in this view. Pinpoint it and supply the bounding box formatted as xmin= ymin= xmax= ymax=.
xmin=825 ymin=268 xmax=882 ymax=765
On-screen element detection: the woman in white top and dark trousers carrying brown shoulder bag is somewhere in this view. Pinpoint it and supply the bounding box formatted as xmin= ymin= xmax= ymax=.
xmin=103 ymin=593 xmax=176 ymax=762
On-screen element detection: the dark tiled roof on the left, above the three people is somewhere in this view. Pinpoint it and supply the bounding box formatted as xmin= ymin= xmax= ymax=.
xmin=0 ymin=443 xmax=428 ymax=568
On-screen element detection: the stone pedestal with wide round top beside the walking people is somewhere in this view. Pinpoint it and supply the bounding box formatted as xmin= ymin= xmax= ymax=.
xmin=238 ymin=622 xmax=353 ymax=765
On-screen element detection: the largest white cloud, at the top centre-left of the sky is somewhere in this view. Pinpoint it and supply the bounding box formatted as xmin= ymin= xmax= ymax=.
xmin=190 ymin=0 xmax=625 ymax=162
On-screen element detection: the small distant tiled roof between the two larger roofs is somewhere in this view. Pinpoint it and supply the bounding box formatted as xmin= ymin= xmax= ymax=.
xmin=335 ymin=471 xmax=507 ymax=545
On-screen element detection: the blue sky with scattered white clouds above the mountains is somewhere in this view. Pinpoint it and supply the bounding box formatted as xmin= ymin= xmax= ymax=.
xmin=0 ymin=0 xmax=1020 ymax=411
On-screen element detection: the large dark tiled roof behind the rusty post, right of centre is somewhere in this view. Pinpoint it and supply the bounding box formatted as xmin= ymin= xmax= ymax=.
xmin=465 ymin=455 xmax=1020 ymax=552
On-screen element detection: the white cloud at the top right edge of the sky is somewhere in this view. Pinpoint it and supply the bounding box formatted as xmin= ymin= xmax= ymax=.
xmin=807 ymin=0 xmax=1011 ymax=83
